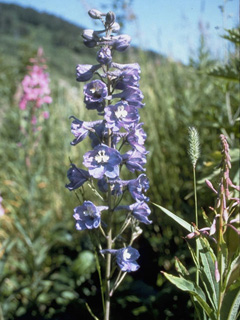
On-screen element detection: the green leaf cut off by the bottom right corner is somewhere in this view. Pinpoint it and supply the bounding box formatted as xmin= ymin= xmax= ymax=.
xmin=220 ymin=285 xmax=240 ymax=320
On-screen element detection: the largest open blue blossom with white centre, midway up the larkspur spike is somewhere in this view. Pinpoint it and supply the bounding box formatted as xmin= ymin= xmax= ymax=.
xmin=83 ymin=144 xmax=122 ymax=179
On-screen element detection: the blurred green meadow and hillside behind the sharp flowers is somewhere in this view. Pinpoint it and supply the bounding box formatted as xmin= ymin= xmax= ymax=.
xmin=0 ymin=4 xmax=240 ymax=320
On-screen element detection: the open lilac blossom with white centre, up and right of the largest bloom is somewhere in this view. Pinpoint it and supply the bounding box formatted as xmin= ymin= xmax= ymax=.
xmin=104 ymin=101 xmax=140 ymax=131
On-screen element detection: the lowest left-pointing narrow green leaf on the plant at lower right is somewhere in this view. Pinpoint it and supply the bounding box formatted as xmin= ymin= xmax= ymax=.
xmin=162 ymin=272 xmax=217 ymax=320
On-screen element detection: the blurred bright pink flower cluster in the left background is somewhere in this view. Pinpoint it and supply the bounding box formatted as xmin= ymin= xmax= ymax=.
xmin=19 ymin=48 xmax=52 ymax=125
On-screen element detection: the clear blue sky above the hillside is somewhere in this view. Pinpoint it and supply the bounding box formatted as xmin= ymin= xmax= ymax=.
xmin=0 ymin=0 xmax=239 ymax=63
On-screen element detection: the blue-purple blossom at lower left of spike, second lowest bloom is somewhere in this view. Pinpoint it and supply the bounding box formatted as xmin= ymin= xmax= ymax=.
xmin=73 ymin=201 xmax=108 ymax=231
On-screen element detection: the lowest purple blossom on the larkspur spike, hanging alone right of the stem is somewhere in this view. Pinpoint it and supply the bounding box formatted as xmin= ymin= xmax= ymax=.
xmin=100 ymin=246 xmax=140 ymax=272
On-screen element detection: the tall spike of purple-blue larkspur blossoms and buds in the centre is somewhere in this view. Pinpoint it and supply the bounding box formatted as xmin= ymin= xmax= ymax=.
xmin=66 ymin=10 xmax=151 ymax=272
